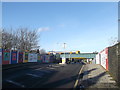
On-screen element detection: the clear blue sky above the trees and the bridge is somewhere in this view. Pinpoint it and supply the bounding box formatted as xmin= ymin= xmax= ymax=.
xmin=2 ymin=2 xmax=118 ymax=52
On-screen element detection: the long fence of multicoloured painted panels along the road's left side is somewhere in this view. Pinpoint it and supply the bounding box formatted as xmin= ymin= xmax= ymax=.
xmin=0 ymin=49 xmax=56 ymax=64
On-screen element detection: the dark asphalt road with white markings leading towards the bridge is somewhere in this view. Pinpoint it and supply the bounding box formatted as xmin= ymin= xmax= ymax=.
xmin=2 ymin=63 xmax=82 ymax=88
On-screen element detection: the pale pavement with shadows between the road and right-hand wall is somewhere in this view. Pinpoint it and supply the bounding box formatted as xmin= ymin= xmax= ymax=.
xmin=79 ymin=64 xmax=120 ymax=90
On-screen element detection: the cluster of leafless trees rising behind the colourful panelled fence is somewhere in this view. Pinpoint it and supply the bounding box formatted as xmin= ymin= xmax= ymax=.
xmin=2 ymin=28 xmax=39 ymax=51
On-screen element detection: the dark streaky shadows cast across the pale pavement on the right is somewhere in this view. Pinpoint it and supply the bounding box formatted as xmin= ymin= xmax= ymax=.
xmin=78 ymin=68 xmax=119 ymax=90
